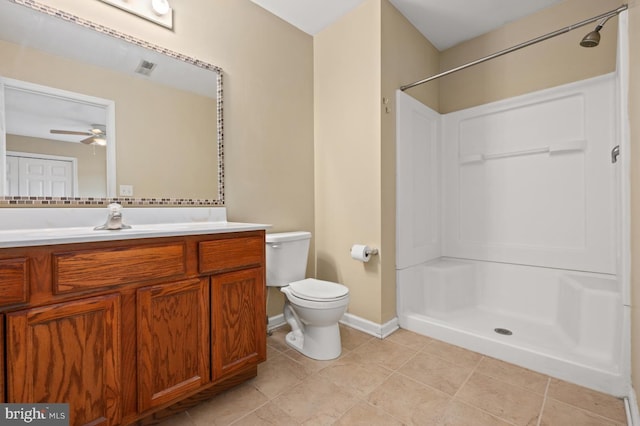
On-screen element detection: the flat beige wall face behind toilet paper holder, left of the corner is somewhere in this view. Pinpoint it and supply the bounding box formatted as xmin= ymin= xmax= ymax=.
xmin=314 ymin=0 xmax=385 ymax=323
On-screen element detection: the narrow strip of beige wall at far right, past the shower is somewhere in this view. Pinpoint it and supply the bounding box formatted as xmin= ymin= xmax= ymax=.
xmin=629 ymin=2 xmax=640 ymax=409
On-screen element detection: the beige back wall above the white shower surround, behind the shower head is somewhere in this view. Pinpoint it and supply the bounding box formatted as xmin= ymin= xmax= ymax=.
xmin=436 ymin=0 xmax=620 ymax=113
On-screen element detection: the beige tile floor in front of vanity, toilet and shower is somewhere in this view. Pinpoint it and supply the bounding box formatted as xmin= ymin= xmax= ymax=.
xmin=161 ymin=326 xmax=626 ymax=426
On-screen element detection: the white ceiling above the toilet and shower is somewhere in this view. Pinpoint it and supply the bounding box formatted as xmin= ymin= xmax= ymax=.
xmin=251 ymin=0 xmax=563 ymax=51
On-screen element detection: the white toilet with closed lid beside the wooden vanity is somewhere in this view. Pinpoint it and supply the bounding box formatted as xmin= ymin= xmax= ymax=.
xmin=266 ymin=232 xmax=349 ymax=360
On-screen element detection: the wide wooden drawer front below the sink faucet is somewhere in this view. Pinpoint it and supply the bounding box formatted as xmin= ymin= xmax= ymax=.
xmin=52 ymin=243 xmax=186 ymax=294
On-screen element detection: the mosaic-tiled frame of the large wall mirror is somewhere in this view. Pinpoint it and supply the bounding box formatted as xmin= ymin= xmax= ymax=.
xmin=0 ymin=0 xmax=225 ymax=208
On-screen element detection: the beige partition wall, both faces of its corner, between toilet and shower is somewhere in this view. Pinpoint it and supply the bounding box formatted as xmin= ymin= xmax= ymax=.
xmin=314 ymin=0 xmax=438 ymax=324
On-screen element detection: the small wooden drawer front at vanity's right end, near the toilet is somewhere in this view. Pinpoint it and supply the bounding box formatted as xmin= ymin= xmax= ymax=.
xmin=198 ymin=236 xmax=264 ymax=274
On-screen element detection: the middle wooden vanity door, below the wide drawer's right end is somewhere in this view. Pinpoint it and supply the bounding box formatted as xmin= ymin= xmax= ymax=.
xmin=137 ymin=279 xmax=210 ymax=411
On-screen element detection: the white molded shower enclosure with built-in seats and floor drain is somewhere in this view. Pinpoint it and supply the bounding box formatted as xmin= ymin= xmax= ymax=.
xmin=396 ymin=70 xmax=629 ymax=396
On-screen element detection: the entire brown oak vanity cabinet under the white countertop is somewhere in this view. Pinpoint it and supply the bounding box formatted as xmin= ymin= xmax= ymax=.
xmin=0 ymin=230 xmax=266 ymax=426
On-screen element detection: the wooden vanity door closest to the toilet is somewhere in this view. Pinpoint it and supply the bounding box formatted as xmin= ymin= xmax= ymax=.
xmin=211 ymin=268 xmax=267 ymax=381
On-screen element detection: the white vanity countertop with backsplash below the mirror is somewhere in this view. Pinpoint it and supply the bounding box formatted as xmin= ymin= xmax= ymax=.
xmin=0 ymin=207 xmax=271 ymax=248
